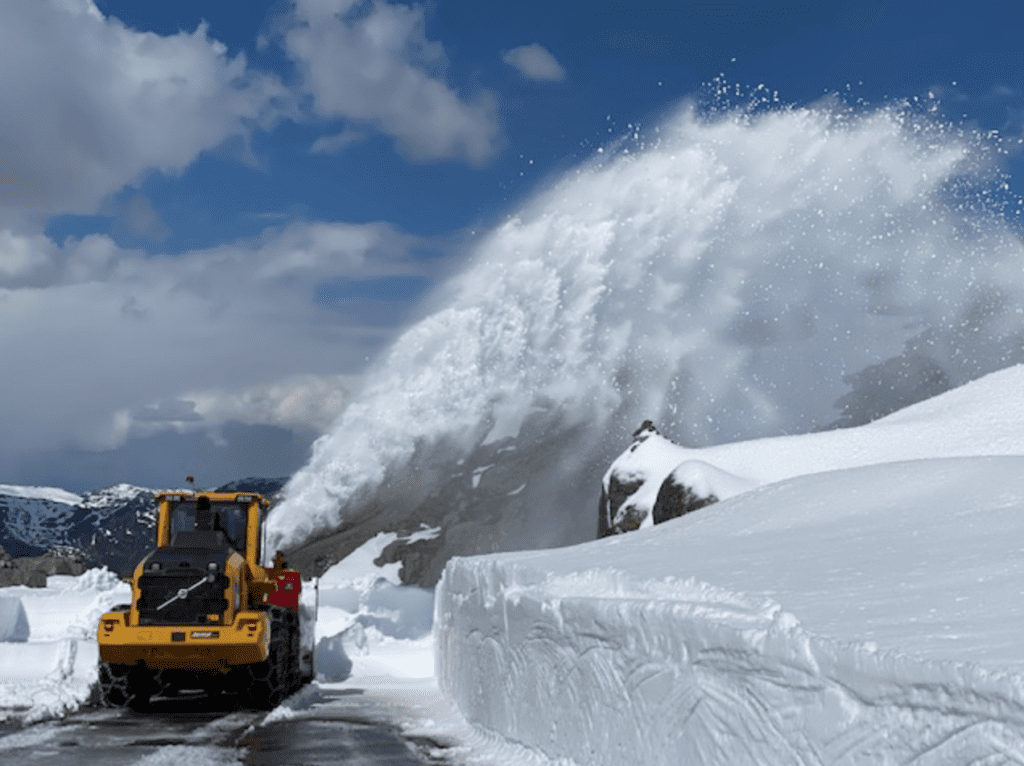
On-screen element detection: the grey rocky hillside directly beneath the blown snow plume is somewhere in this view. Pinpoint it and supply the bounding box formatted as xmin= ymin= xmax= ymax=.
xmin=286 ymin=414 xmax=611 ymax=588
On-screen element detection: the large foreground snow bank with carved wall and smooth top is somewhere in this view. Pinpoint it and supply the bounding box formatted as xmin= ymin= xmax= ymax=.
xmin=435 ymin=458 xmax=1024 ymax=766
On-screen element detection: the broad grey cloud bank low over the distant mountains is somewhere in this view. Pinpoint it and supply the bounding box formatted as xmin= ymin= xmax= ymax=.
xmin=0 ymin=222 xmax=432 ymax=453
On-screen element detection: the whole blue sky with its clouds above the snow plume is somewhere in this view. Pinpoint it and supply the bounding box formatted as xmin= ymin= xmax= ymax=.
xmin=0 ymin=0 xmax=1024 ymax=488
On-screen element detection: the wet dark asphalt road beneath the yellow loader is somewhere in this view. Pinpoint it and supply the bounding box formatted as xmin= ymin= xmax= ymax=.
xmin=0 ymin=689 xmax=446 ymax=766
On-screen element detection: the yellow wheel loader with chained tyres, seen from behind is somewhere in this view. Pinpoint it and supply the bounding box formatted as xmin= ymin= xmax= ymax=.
xmin=96 ymin=492 xmax=313 ymax=710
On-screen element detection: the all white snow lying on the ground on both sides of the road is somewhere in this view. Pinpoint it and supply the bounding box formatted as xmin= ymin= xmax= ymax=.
xmin=9 ymin=367 xmax=1024 ymax=766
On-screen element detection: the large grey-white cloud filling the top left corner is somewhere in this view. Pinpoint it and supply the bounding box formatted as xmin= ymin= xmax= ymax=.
xmin=0 ymin=0 xmax=286 ymax=226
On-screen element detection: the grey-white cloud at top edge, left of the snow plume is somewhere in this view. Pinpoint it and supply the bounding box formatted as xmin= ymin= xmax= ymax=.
xmin=283 ymin=0 xmax=501 ymax=166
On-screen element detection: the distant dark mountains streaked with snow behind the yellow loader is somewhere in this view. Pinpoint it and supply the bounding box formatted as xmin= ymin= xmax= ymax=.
xmin=0 ymin=476 xmax=288 ymax=575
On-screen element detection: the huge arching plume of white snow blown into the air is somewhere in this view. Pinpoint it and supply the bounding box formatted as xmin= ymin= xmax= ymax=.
xmin=269 ymin=91 xmax=1024 ymax=569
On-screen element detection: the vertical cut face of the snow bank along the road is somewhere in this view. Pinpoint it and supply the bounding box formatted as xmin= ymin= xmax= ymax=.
xmin=436 ymin=559 xmax=1024 ymax=766
